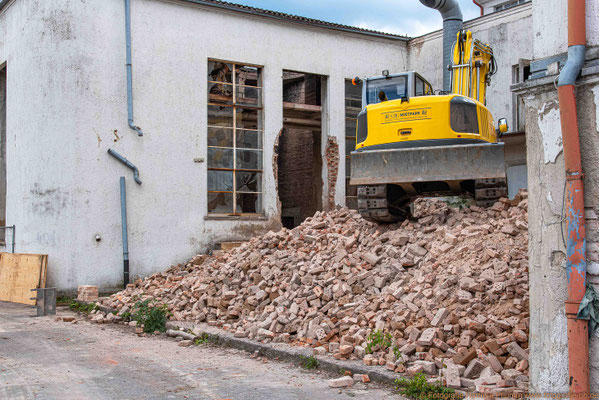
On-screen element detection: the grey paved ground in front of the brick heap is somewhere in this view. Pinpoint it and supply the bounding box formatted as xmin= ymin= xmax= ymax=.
xmin=0 ymin=302 xmax=401 ymax=400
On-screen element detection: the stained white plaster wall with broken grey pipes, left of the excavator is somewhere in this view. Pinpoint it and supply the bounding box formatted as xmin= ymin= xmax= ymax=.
xmin=0 ymin=0 xmax=407 ymax=289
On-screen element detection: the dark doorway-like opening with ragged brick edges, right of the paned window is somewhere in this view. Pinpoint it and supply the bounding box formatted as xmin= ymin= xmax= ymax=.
xmin=277 ymin=71 xmax=324 ymax=229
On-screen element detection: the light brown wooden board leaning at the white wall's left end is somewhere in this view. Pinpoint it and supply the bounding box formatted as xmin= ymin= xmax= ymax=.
xmin=0 ymin=253 xmax=48 ymax=305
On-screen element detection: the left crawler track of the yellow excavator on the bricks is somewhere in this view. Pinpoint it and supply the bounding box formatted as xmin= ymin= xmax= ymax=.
xmin=358 ymin=185 xmax=411 ymax=223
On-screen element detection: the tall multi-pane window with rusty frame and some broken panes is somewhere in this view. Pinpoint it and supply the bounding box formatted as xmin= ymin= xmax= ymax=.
xmin=208 ymin=60 xmax=263 ymax=215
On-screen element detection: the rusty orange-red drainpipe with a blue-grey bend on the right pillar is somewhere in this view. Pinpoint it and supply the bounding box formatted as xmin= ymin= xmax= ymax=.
xmin=558 ymin=0 xmax=590 ymax=399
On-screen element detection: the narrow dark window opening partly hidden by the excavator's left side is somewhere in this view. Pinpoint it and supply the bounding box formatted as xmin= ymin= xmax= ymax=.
xmin=345 ymin=79 xmax=362 ymax=210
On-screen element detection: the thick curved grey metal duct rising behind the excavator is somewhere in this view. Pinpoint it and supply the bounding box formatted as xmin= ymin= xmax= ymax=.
xmin=420 ymin=0 xmax=464 ymax=92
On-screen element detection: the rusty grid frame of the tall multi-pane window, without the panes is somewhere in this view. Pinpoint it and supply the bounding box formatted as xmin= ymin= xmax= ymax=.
xmin=206 ymin=58 xmax=264 ymax=217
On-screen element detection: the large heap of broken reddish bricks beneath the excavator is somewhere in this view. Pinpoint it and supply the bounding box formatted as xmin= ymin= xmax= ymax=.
xmin=103 ymin=192 xmax=529 ymax=395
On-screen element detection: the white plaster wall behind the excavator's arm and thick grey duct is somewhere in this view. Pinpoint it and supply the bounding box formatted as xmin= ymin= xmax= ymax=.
xmin=409 ymin=4 xmax=533 ymax=130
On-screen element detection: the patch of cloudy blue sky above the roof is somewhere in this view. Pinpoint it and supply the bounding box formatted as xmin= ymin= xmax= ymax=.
xmin=228 ymin=0 xmax=480 ymax=37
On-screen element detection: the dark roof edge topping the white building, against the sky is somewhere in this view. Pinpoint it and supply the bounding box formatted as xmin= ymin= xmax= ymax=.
xmin=0 ymin=0 xmax=411 ymax=42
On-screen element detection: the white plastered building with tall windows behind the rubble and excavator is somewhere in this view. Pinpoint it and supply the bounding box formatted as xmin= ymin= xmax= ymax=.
xmin=0 ymin=0 xmax=532 ymax=290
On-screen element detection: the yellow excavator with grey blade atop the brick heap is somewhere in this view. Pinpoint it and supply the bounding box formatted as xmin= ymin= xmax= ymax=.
xmin=350 ymin=30 xmax=507 ymax=222
